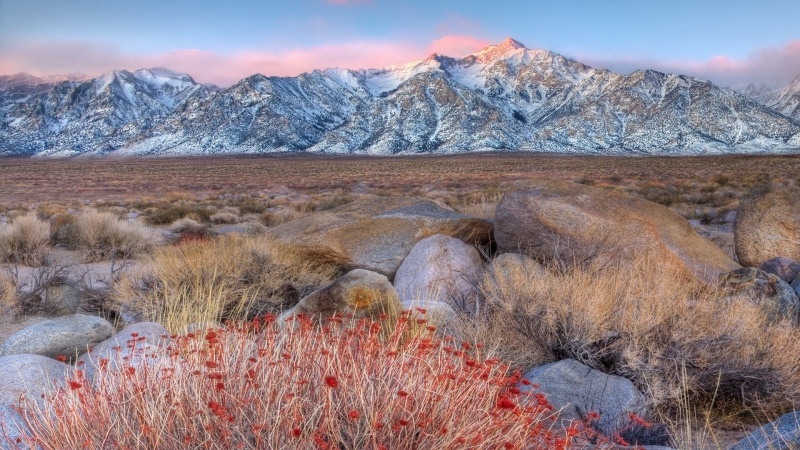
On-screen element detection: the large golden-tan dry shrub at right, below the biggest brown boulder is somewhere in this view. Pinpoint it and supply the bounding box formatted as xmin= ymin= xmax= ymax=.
xmin=461 ymin=251 xmax=800 ymax=420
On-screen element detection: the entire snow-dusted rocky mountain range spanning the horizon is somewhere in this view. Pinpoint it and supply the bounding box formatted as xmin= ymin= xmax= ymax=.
xmin=0 ymin=39 xmax=800 ymax=155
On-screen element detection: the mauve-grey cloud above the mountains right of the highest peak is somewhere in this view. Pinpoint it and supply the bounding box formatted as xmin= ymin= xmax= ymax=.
xmin=576 ymin=40 xmax=800 ymax=87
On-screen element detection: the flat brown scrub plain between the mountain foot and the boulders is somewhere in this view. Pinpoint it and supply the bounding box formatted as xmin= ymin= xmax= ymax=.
xmin=0 ymin=153 xmax=800 ymax=224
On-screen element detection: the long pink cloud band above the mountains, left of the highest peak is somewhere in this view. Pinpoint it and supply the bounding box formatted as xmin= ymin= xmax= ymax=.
xmin=0 ymin=35 xmax=486 ymax=86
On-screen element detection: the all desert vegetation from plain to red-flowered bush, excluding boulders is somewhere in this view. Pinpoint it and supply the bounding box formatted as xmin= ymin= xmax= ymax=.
xmin=0 ymin=155 xmax=800 ymax=449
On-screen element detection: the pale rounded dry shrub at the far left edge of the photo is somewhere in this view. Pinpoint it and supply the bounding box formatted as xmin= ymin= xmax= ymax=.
xmin=0 ymin=213 xmax=50 ymax=266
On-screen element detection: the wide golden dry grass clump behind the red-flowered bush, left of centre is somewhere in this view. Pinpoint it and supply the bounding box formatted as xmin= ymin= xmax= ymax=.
xmin=113 ymin=235 xmax=347 ymax=330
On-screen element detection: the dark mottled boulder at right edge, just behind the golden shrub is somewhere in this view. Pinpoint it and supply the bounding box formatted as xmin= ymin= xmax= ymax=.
xmin=720 ymin=267 xmax=800 ymax=323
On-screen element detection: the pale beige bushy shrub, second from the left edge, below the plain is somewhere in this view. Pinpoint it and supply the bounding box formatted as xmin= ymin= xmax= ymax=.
xmin=75 ymin=210 xmax=158 ymax=262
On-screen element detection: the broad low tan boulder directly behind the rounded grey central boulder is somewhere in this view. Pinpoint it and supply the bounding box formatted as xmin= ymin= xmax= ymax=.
xmin=269 ymin=197 xmax=492 ymax=279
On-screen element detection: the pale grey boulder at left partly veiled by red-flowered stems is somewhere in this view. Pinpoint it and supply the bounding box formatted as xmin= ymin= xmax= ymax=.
xmin=76 ymin=322 xmax=170 ymax=381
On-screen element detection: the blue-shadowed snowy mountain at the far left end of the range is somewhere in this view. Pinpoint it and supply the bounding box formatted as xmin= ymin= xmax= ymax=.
xmin=0 ymin=68 xmax=214 ymax=156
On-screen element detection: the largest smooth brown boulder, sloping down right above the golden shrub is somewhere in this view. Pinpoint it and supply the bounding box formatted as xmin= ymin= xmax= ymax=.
xmin=495 ymin=180 xmax=740 ymax=282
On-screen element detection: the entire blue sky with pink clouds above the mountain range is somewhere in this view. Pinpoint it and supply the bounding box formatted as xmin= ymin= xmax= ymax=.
xmin=0 ymin=0 xmax=800 ymax=87
